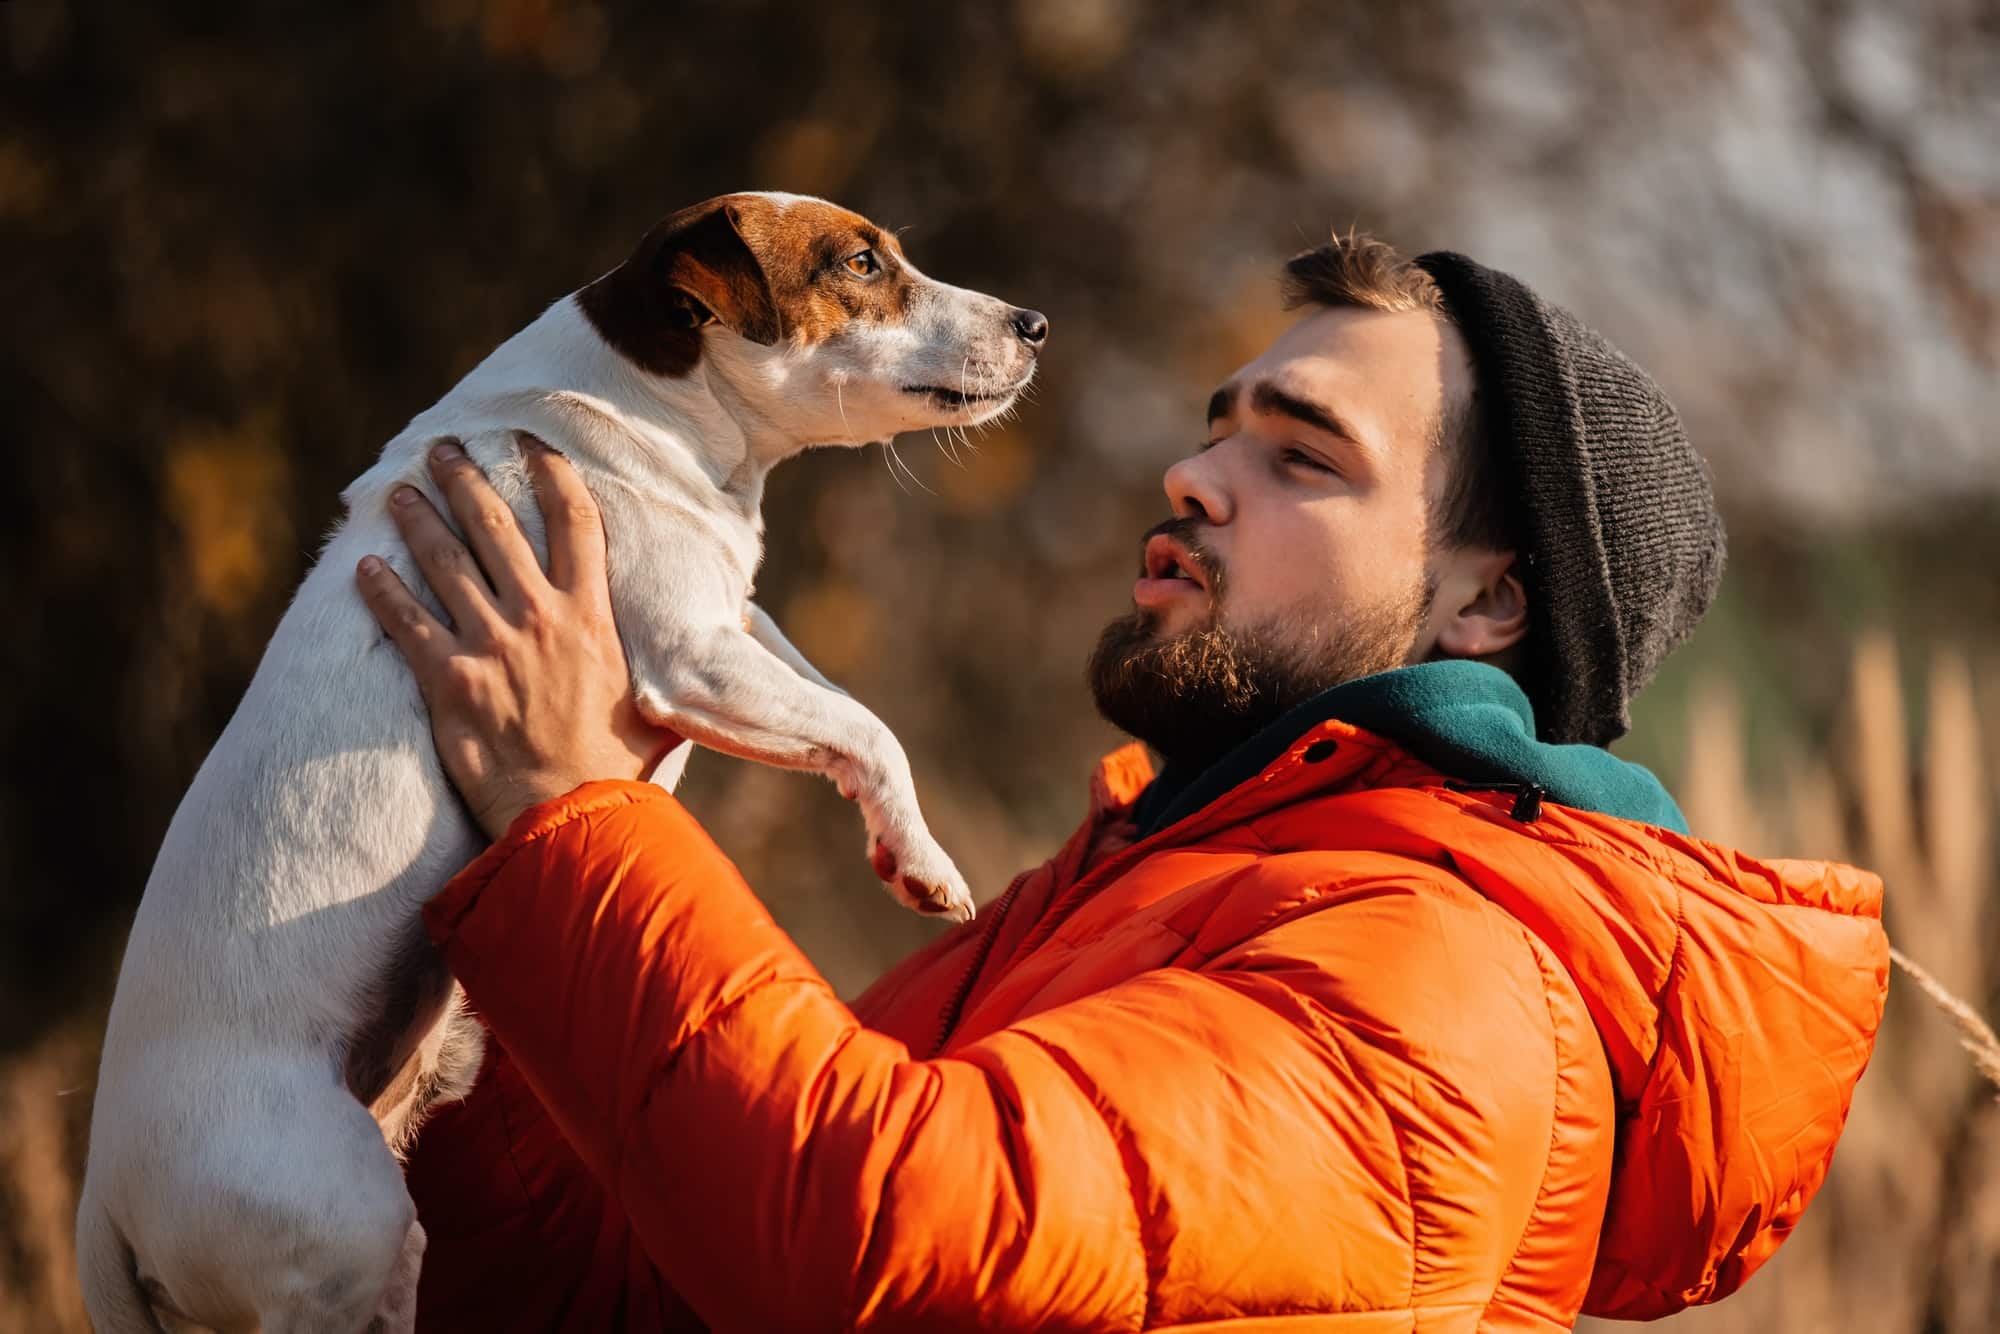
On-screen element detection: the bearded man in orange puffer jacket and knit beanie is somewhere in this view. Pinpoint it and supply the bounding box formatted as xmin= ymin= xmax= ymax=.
xmin=360 ymin=238 xmax=1888 ymax=1334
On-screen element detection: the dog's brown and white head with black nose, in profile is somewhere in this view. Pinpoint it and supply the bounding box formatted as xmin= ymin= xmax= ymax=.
xmin=578 ymin=194 xmax=1048 ymax=446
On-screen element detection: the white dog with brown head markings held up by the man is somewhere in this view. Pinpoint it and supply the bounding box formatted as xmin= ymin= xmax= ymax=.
xmin=76 ymin=194 xmax=1048 ymax=1334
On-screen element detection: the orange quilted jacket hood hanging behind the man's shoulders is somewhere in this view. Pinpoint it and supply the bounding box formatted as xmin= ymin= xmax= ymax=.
xmin=1450 ymin=796 xmax=1888 ymax=1320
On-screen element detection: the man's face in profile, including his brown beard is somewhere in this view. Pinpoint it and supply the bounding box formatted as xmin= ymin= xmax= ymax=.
xmin=1090 ymin=298 xmax=1472 ymax=764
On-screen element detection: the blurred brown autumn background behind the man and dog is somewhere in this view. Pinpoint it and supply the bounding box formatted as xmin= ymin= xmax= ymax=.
xmin=0 ymin=0 xmax=2000 ymax=1332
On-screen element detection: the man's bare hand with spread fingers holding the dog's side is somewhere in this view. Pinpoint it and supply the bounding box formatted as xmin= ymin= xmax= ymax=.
xmin=356 ymin=440 xmax=680 ymax=838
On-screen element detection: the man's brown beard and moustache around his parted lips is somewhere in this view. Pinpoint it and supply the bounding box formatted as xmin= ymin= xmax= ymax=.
xmin=1090 ymin=520 xmax=1434 ymax=768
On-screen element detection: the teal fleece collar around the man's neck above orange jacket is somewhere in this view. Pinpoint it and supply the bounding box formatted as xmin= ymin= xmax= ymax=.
xmin=1134 ymin=658 xmax=1688 ymax=836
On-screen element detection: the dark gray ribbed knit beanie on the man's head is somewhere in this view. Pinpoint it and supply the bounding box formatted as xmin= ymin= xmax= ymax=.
xmin=1416 ymin=250 xmax=1724 ymax=746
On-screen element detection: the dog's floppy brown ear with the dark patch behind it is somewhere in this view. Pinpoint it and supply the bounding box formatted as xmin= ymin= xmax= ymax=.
xmin=576 ymin=200 xmax=784 ymax=378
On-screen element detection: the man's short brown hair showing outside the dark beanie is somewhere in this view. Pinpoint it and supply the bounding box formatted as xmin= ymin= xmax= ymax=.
xmin=1282 ymin=230 xmax=1520 ymax=552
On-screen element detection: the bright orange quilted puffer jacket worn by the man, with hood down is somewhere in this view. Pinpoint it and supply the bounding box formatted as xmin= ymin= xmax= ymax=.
xmin=410 ymin=722 xmax=1888 ymax=1334
